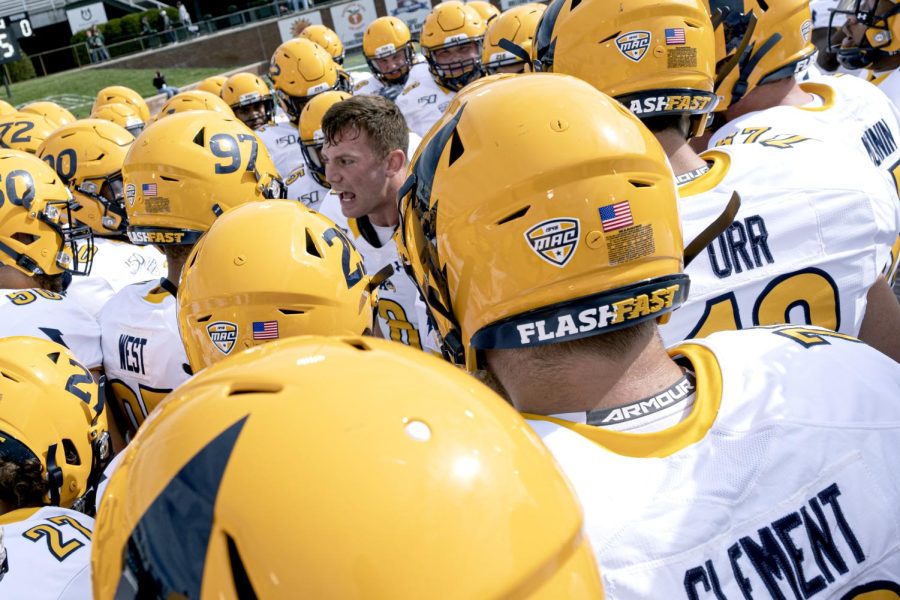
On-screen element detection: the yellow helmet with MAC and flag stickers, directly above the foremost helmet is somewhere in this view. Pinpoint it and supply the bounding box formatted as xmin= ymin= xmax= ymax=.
xmin=178 ymin=200 xmax=375 ymax=373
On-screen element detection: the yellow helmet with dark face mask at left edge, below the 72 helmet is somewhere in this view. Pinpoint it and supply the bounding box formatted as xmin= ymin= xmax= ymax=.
xmin=0 ymin=150 xmax=94 ymax=277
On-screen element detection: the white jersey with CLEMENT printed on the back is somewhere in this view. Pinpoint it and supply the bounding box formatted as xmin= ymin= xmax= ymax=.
xmin=526 ymin=326 xmax=900 ymax=600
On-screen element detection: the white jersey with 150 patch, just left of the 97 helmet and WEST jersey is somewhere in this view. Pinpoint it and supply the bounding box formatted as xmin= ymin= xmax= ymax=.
xmin=66 ymin=237 xmax=166 ymax=319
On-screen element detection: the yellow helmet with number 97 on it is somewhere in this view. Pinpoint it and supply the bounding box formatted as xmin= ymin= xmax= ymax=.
xmin=122 ymin=110 xmax=286 ymax=246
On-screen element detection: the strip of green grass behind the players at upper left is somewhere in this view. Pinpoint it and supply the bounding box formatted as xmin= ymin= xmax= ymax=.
xmin=0 ymin=69 xmax=229 ymax=118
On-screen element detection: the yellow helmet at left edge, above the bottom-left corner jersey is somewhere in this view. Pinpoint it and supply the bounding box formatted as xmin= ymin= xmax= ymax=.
xmin=0 ymin=337 xmax=111 ymax=510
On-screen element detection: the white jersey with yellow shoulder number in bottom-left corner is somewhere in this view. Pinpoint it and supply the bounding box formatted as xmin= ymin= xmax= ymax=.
xmin=0 ymin=506 xmax=94 ymax=600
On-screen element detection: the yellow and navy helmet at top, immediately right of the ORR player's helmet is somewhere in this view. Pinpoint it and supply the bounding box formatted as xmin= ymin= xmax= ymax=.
xmin=709 ymin=0 xmax=816 ymax=111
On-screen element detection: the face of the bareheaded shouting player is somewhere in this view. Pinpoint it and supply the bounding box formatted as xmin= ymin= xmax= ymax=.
xmin=322 ymin=129 xmax=391 ymax=219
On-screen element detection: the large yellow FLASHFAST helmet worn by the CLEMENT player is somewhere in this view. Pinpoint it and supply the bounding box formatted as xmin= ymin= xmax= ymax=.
xmin=399 ymin=73 xmax=688 ymax=370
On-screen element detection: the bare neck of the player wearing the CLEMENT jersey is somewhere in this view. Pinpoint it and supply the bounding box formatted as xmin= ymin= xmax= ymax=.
xmin=487 ymin=330 xmax=683 ymax=415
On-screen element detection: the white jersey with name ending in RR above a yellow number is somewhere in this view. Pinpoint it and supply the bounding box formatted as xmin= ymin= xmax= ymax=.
xmin=660 ymin=139 xmax=900 ymax=346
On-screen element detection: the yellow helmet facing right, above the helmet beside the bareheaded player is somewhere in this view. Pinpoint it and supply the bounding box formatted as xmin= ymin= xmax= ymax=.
xmin=269 ymin=38 xmax=350 ymax=125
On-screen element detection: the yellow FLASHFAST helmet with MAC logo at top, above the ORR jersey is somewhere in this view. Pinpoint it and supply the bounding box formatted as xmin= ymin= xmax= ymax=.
xmin=532 ymin=0 xmax=716 ymax=136
